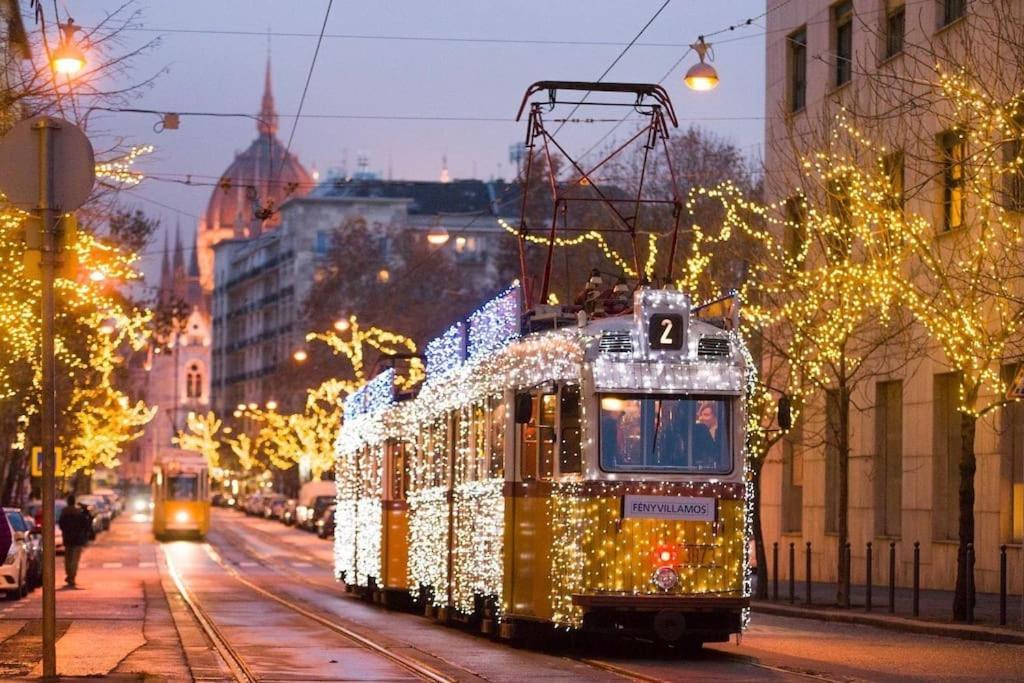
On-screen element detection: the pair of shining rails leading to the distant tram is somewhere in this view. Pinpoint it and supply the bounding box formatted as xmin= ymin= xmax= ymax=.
xmin=162 ymin=543 xmax=456 ymax=683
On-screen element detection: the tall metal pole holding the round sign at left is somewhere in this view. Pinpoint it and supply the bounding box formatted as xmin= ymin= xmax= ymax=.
xmin=33 ymin=120 xmax=57 ymax=679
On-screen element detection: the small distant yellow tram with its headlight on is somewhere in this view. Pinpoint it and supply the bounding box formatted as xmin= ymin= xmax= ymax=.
xmin=151 ymin=452 xmax=210 ymax=541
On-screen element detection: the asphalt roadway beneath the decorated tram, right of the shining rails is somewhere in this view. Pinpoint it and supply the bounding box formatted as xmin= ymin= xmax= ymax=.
xmin=209 ymin=510 xmax=1024 ymax=681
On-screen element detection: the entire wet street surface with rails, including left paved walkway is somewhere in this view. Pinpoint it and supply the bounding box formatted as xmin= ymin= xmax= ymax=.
xmin=0 ymin=510 xmax=1024 ymax=681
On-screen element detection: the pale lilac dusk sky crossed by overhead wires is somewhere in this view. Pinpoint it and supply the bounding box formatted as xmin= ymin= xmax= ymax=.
xmin=61 ymin=0 xmax=765 ymax=275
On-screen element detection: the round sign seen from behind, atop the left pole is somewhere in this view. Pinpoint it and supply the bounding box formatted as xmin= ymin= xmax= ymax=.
xmin=0 ymin=116 xmax=96 ymax=211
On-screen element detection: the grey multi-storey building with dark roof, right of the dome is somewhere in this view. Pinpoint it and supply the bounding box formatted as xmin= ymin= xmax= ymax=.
xmin=213 ymin=177 xmax=511 ymax=415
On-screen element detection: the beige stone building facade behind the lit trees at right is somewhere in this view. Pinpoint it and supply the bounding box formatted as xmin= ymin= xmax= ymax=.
xmin=761 ymin=0 xmax=1024 ymax=591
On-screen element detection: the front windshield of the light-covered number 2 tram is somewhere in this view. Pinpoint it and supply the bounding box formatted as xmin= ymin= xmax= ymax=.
xmin=600 ymin=395 xmax=732 ymax=474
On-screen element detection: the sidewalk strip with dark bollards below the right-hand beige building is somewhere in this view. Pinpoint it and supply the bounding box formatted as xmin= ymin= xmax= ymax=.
xmin=753 ymin=581 xmax=1024 ymax=644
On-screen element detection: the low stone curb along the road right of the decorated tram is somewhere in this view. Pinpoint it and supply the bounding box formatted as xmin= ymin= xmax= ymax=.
xmin=751 ymin=600 xmax=1024 ymax=645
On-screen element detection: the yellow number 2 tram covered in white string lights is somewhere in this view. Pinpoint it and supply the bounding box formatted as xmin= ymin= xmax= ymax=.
xmin=335 ymin=287 xmax=752 ymax=645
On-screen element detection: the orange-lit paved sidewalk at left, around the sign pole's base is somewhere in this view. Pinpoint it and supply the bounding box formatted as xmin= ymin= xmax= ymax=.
xmin=0 ymin=515 xmax=193 ymax=681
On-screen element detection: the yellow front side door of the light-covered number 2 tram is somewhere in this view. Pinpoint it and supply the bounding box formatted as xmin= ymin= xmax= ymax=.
xmin=508 ymin=386 xmax=581 ymax=618
